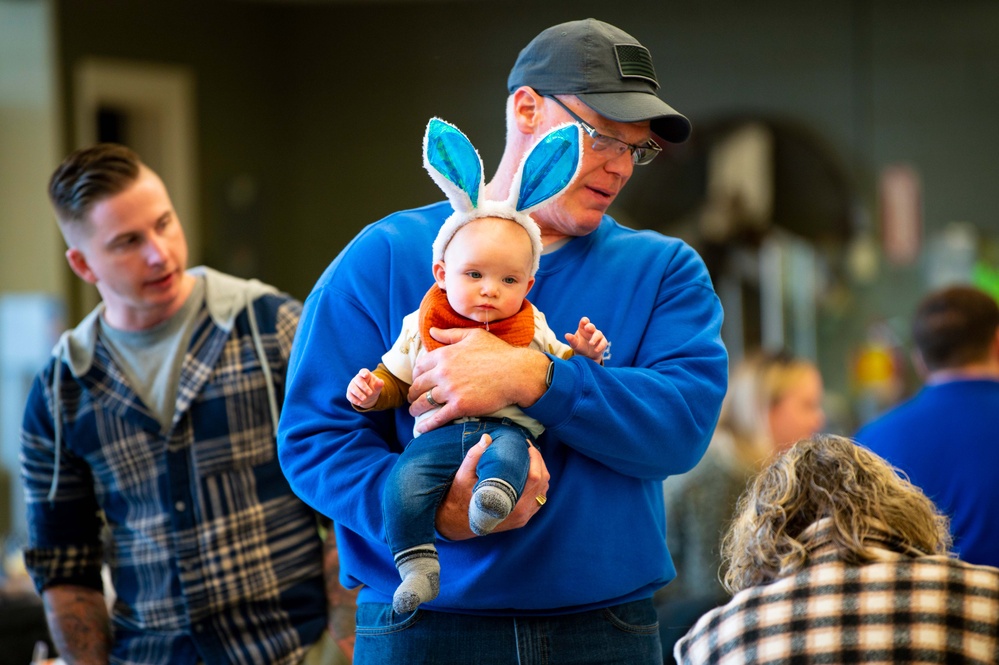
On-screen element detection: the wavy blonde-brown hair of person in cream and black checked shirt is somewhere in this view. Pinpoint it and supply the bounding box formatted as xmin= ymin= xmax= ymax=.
xmin=722 ymin=434 xmax=951 ymax=593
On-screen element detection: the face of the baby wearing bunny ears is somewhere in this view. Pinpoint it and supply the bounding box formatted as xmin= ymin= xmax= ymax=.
xmin=434 ymin=217 xmax=534 ymax=323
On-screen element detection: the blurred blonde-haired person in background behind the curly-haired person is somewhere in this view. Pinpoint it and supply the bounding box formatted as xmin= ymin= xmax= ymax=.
xmin=655 ymin=352 xmax=825 ymax=663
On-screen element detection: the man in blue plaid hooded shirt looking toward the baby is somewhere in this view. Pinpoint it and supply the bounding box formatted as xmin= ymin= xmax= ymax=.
xmin=21 ymin=144 xmax=356 ymax=665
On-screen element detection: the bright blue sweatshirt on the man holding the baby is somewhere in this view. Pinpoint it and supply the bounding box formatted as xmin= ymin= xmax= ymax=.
xmin=278 ymin=203 xmax=728 ymax=614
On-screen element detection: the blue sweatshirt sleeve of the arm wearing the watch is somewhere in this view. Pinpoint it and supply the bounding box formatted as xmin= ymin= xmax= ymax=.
xmin=525 ymin=236 xmax=728 ymax=479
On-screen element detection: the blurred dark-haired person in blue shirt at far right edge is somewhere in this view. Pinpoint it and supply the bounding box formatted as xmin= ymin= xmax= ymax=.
xmin=855 ymin=285 xmax=999 ymax=566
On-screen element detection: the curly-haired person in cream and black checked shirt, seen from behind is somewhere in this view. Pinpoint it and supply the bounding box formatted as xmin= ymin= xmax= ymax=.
xmin=674 ymin=436 xmax=999 ymax=665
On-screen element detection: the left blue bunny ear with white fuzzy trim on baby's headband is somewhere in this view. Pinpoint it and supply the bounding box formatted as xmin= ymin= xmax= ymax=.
xmin=423 ymin=118 xmax=484 ymax=211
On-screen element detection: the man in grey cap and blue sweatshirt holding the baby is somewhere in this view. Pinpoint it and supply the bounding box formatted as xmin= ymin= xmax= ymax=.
xmin=279 ymin=19 xmax=728 ymax=665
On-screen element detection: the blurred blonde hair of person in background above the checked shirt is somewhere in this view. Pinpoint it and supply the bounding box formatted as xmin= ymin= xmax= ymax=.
xmin=718 ymin=352 xmax=817 ymax=467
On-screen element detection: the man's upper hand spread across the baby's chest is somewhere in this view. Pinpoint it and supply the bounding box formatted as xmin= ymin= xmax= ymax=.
xmin=409 ymin=328 xmax=550 ymax=433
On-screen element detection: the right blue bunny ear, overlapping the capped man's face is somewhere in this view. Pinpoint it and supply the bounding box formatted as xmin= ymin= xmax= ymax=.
xmin=514 ymin=124 xmax=582 ymax=212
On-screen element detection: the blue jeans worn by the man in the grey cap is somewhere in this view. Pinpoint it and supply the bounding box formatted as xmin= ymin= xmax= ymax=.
xmin=354 ymin=596 xmax=663 ymax=665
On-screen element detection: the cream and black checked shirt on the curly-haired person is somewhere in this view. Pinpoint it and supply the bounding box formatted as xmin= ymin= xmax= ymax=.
xmin=674 ymin=550 xmax=999 ymax=665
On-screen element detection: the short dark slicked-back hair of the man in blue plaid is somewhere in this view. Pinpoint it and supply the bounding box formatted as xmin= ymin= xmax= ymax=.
xmin=49 ymin=143 xmax=142 ymax=225
